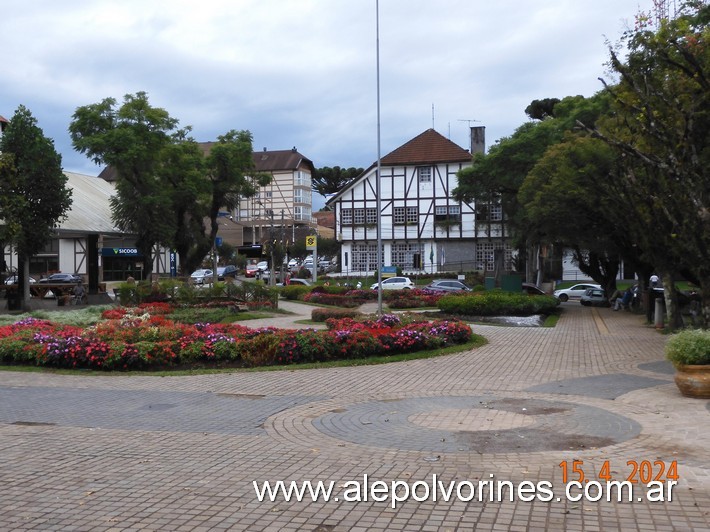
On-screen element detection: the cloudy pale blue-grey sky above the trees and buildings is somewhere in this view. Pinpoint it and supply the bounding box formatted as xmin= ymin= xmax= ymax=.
xmin=0 ymin=0 xmax=651 ymax=208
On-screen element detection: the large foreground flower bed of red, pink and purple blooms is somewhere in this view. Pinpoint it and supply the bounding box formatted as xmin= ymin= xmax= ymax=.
xmin=0 ymin=303 xmax=472 ymax=370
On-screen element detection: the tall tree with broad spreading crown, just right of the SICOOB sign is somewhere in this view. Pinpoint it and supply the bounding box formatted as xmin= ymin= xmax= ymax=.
xmin=69 ymin=92 xmax=178 ymax=274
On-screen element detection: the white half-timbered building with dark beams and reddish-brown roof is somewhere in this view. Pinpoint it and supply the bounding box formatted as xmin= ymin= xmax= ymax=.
xmin=327 ymin=127 xmax=512 ymax=273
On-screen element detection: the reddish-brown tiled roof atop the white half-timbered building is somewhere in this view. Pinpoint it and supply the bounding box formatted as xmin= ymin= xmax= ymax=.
xmin=381 ymin=129 xmax=471 ymax=166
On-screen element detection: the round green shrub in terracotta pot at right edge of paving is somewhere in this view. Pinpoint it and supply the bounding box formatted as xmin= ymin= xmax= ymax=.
xmin=665 ymin=329 xmax=710 ymax=399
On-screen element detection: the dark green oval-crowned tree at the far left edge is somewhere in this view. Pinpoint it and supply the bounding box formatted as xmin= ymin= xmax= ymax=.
xmin=0 ymin=106 xmax=71 ymax=308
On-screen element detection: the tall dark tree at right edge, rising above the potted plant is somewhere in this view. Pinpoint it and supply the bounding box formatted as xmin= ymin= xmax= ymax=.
xmin=595 ymin=0 xmax=710 ymax=323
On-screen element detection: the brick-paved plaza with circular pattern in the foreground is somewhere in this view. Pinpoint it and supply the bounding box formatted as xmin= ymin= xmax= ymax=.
xmin=0 ymin=302 xmax=710 ymax=532
